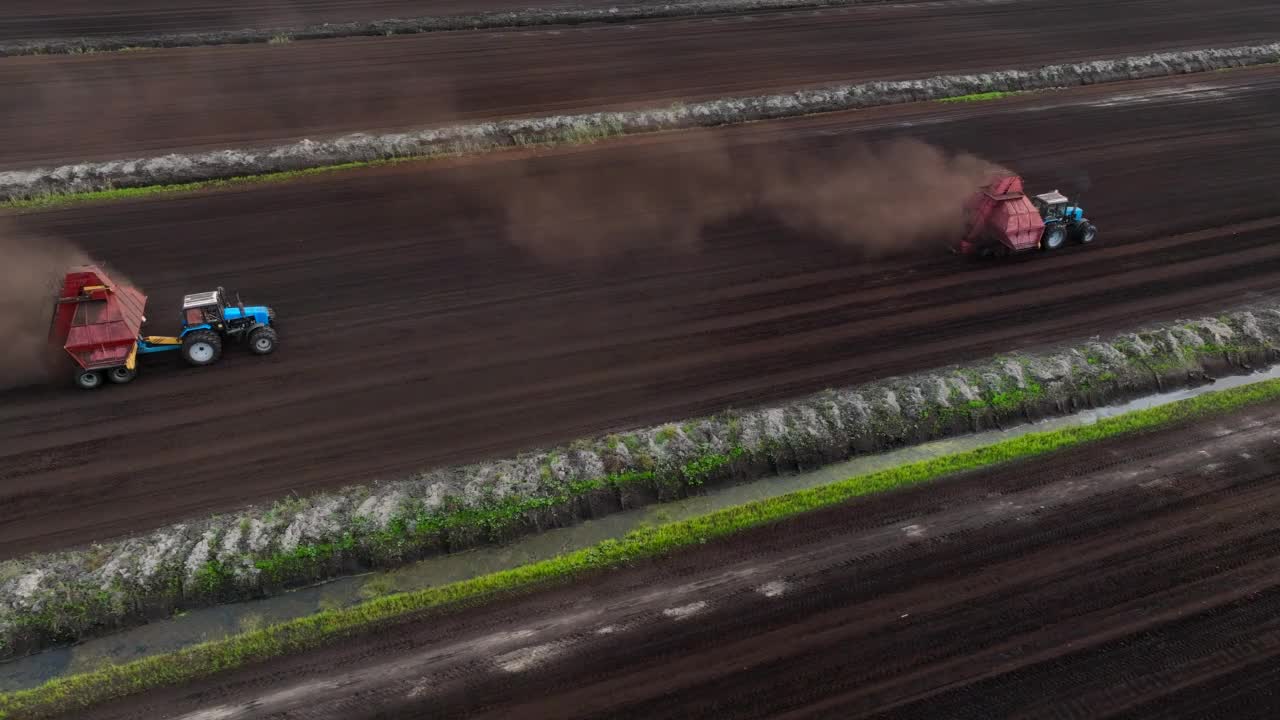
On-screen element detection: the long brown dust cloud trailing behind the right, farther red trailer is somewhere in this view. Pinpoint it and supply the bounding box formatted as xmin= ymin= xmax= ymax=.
xmin=484 ymin=133 xmax=1002 ymax=260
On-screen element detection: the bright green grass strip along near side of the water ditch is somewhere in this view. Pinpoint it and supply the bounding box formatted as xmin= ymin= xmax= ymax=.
xmin=0 ymin=380 xmax=1280 ymax=720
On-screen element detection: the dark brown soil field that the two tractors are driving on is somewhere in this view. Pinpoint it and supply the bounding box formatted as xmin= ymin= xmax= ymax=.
xmin=0 ymin=69 xmax=1280 ymax=557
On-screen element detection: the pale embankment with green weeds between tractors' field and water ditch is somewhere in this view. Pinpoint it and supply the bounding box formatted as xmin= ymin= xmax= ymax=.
xmin=0 ymin=298 xmax=1280 ymax=653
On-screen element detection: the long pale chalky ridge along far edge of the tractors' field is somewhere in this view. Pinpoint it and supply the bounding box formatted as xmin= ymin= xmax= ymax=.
xmin=0 ymin=42 xmax=1280 ymax=200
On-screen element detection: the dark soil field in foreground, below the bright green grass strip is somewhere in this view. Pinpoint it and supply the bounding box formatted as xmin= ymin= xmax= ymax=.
xmin=74 ymin=394 xmax=1280 ymax=720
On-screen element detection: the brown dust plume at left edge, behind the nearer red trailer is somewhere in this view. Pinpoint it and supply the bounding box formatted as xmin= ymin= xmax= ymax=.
xmin=0 ymin=220 xmax=88 ymax=389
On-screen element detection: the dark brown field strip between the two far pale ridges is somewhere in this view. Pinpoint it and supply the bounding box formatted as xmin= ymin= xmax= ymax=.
xmin=0 ymin=0 xmax=1280 ymax=169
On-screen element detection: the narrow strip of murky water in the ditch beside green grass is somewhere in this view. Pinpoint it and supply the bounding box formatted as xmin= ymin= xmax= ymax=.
xmin=0 ymin=365 xmax=1280 ymax=692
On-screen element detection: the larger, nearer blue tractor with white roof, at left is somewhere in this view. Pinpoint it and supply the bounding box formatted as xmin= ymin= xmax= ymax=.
xmin=138 ymin=287 xmax=276 ymax=366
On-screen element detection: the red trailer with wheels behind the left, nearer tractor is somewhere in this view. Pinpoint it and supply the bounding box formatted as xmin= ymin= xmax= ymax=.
xmin=49 ymin=265 xmax=147 ymax=387
